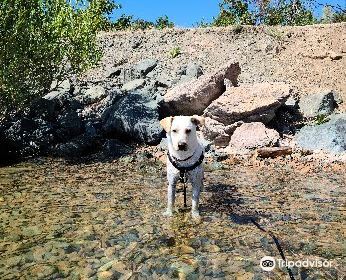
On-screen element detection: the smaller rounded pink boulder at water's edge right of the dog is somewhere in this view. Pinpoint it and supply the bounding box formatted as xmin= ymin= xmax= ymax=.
xmin=229 ymin=122 xmax=280 ymax=149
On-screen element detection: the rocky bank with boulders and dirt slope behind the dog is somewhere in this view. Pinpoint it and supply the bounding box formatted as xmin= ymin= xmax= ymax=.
xmin=0 ymin=24 xmax=346 ymax=164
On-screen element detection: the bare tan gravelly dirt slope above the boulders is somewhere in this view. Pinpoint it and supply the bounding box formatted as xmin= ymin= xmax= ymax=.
xmin=85 ymin=23 xmax=346 ymax=110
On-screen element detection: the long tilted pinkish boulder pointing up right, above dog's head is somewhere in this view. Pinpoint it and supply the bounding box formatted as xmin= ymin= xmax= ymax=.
xmin=162 ymin=62 xmax=240 ymax=115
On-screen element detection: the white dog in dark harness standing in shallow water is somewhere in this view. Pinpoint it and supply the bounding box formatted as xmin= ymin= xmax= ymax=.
xmin=160 ymin=115 xmax=204 ymax=218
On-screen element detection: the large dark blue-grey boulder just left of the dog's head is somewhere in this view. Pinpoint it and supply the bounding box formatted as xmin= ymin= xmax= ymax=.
xmin=102 ymin=92 xmax=162 ymax=144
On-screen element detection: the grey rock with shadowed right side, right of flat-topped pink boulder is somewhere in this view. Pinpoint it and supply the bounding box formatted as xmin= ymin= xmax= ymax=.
xmin=299 ymin=90 xmax=335 ymax=118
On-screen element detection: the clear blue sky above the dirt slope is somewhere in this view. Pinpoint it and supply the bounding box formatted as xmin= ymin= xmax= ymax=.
xmin=112 ymin=0 xmax=346 ymax=27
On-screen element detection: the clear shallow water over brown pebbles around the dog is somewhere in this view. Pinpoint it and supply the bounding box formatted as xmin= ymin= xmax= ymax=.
xmin=0 ymin=157 xmax=346 ymax=279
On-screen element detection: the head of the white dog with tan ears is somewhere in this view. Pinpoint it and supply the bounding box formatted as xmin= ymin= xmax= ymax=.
xmin=160 ymin=115 xmax=204 ymax=151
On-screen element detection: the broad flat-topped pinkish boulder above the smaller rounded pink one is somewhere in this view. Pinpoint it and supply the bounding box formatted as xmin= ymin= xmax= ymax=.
xmin=204 ymin=83 xmax=291 ymax=125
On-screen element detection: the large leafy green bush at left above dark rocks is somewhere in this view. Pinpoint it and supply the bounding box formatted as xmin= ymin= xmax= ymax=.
xmin=0 ymin=0 xmax=117 ymax=112
